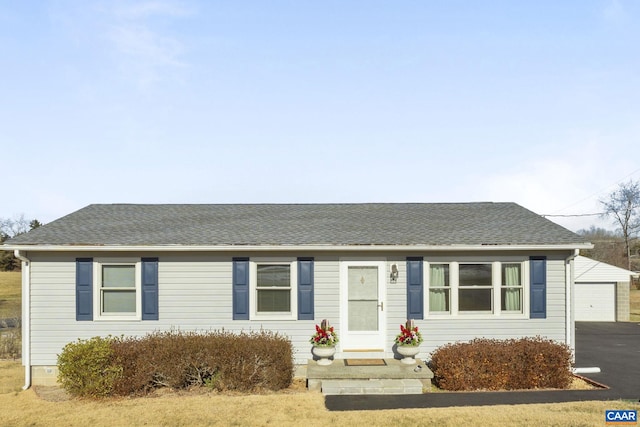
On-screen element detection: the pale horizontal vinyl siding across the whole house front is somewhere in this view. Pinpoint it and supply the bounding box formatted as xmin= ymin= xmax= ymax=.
xmin=29 ymin=252 xmax=568 ymax=366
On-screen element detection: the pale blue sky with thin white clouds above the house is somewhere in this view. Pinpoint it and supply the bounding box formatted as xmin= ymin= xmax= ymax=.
xmin=0 ymin=0 xmax=640 ymax=230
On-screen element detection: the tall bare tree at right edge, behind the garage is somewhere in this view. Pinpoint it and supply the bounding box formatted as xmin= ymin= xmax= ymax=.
xmin=600 ymin=181 xmax=640 ymax=270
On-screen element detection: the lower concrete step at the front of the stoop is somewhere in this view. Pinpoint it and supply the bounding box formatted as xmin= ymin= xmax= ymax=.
xmin=321 ymin=379 xmax=423 ymax=394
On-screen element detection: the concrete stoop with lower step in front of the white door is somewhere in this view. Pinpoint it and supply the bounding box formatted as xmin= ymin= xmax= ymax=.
xmin=306 ymin=359 xmax=433 ymax=395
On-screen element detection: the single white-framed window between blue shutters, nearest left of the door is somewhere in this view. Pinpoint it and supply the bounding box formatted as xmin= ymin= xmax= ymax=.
xmin=249 ymin=258 xmax=298 ymax=320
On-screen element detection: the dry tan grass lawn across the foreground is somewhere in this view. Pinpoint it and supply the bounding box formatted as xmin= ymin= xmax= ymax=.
xmin=0 ymin=362 xmax=640 ymax=426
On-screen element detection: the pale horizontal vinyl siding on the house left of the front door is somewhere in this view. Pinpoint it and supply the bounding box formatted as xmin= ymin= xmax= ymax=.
xmin=31 ymin=253 xmax=340 ymax=365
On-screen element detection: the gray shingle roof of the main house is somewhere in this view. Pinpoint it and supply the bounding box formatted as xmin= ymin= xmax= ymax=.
xmin=7 ymin=203 xmax=585 ymax=246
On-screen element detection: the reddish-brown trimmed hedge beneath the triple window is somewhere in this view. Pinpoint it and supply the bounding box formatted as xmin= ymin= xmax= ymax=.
xmin=430 ymin=337 xmax=572 ymax=391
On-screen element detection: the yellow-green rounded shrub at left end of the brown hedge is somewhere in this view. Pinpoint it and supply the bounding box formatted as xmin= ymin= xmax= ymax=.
xmin=58 ymin=336 xmax=122 ymax=397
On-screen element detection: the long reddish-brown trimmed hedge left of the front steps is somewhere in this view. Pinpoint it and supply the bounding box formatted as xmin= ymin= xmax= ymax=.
xmin=61 ymin=331 xmax=294 ymax=397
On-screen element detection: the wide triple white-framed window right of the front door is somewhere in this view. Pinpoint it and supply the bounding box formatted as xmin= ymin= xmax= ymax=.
xmin=425 ymin=260 xmax=528 ymax=318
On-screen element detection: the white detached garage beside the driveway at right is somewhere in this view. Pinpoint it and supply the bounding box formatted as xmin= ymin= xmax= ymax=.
xmin=574 ymin=256 xmax=637 ymax=322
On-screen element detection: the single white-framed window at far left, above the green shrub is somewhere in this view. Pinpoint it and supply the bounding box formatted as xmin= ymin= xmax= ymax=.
xmin=93 ymin=258 xmax=142 ymax=320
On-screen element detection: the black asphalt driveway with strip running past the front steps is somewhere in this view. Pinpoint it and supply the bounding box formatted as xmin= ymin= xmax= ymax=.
xmin=325 ymin=322 xmax=640 ymax=411
